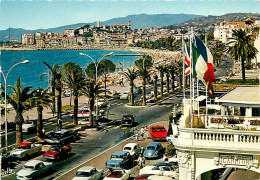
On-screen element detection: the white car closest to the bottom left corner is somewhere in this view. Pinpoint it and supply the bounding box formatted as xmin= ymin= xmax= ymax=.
xmin=16 ymin=160 xmax=52 ymax=179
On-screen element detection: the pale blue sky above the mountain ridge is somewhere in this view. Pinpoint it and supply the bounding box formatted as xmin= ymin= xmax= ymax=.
xmin=0 ymin=0 xmax=260 ymax=30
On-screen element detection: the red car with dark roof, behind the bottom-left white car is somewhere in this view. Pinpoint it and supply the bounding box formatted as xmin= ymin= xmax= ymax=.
xmin=43 ymin=145 xmax=71 ymax=160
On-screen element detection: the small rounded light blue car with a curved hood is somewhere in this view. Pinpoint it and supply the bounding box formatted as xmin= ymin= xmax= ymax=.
xmin=144 ymin=142 xmax=165 ymax=159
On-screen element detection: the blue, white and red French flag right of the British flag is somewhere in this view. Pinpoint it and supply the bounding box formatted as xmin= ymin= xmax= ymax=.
xmin=192 ymin=36 xmax=215 ymax=95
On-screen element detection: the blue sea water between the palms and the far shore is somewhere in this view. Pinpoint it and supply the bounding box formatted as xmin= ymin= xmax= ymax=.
xmin=0 ymin=50 xmax=138 ymax=93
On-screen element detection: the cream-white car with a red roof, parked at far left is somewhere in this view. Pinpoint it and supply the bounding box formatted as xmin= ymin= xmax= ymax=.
xmin=10 ymin=142 xmax=42 ymax=159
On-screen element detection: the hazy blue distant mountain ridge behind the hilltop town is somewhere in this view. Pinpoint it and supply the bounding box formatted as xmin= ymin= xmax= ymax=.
xmin=0 ymin=14 xmax=203 ymax=41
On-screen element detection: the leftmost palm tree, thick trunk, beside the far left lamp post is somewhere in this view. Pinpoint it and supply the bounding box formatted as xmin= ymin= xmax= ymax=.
xmin=6 ymin=77 xmax=32 ymax=143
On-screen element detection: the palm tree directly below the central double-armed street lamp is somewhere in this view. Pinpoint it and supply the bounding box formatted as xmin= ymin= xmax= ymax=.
xmin=82 ymin=79 xmax=104 ymax=127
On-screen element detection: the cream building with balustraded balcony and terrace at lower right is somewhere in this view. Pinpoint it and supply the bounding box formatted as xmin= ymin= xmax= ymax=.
xmin=168 ymin=87 xmax=260 ymax=180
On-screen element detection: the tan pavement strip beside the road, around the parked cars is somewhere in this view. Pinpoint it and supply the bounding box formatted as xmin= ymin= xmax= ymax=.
xmin=55 ymin=121 xmax=169 ymax=180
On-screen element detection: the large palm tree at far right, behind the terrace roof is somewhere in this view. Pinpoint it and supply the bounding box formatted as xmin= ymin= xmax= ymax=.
xmin=227 ymin=29 xmax=258 ymax=81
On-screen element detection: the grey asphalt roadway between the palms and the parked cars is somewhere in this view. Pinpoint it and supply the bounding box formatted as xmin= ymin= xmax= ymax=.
xmin=3 ymin=90 xmax=182 ymax=179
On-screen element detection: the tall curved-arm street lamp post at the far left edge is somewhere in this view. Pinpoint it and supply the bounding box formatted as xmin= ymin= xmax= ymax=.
xmin=0 ymin=60 xmax=29 ymax=153
